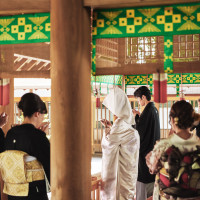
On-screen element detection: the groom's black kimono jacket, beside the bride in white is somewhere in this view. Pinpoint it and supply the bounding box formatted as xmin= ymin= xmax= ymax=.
xmin=135 ymin=102 xmax=160 ymax=183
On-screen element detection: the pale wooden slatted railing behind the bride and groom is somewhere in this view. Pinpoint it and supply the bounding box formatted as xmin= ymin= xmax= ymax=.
xmin=91 ymin=96 xmax=199 ymax=153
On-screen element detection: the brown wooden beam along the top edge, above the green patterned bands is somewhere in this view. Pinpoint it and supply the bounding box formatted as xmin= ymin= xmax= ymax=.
xmin=0 ymin=0 xmax=199 ymax=15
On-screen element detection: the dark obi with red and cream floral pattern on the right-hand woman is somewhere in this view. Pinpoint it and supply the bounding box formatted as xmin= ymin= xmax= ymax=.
xmin=158 ymin=145 xmax=200 ymax=198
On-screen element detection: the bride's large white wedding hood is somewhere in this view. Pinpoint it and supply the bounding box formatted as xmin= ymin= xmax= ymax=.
xmin=103 ymin=86 xmax=135 ymax=125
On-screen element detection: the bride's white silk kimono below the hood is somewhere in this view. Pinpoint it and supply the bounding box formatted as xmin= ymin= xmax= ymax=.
xmin=101 ymin=119 xmax=140 ymax=200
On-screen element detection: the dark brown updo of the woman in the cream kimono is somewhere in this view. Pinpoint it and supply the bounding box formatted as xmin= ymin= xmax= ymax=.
xmin=169 ymin=100 xmax=195 ymax=129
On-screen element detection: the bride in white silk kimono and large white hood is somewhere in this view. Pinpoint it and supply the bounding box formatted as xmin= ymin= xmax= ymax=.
xmin=101 ymin=87 xmax=140 ymax=200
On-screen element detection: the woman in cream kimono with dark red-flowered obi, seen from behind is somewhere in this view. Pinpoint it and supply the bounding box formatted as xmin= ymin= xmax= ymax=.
xmin=146 ymin=100 xmax=200 ymax=200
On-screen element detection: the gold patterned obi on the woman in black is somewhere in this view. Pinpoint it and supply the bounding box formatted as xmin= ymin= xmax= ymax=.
xmin=0 ymin=150 xmax=44 ymax=196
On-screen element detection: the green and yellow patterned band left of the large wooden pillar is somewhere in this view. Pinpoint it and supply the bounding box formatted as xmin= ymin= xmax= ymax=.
xmin=0 ymin=13 xmax=51 ymax=44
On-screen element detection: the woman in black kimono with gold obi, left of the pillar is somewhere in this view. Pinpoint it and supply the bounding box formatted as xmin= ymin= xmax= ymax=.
xmin=1 ymin=93 xmax=50 ymax=200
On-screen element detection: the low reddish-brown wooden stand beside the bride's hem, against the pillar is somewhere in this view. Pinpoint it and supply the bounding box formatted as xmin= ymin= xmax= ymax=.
xmin=91 ymin=174 xmax=101 ymax=200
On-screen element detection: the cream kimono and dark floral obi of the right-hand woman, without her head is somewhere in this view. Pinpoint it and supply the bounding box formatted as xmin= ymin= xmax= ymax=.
xmin=146 ymin=134 xmax=200 ymax=200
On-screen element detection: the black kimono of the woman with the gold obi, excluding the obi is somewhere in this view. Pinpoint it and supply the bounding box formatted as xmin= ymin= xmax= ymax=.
xmin=5 ymin=124 xmax=50 ymax=200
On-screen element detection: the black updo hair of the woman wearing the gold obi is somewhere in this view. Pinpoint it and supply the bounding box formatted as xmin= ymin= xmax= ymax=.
xmin=18 ymin=93 xmax=47 ymax=117
